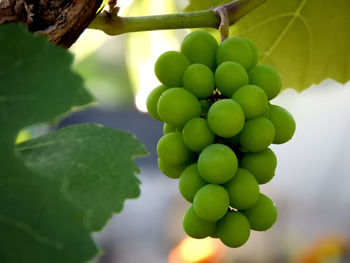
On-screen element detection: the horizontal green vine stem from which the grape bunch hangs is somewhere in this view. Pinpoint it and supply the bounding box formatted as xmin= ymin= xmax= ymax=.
xmin=89 ymin=0 xmax=268 ymax=35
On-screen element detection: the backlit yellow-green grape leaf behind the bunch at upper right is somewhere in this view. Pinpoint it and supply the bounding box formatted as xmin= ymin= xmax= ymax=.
xmin=185 ymin=0 xmax=350 ymax=91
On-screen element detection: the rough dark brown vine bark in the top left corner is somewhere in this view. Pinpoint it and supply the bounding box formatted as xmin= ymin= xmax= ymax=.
xmin=0 ymin=0 xmax=102 ymax=48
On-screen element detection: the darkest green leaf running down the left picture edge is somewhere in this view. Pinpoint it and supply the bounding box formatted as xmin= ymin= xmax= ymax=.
xmin=0 ymin=24 xmax=97 ymax=263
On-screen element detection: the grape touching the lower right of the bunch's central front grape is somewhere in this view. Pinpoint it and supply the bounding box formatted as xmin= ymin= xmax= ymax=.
xmin=224 ymin=168 xmax=259 ymax=210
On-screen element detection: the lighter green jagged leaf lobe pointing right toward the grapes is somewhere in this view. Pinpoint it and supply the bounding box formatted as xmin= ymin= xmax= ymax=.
xmin=16 ymin=124 xmax=147 ymax=231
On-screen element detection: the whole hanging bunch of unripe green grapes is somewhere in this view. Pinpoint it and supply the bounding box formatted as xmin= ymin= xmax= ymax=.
xmin=147 ymin=30 xmax=295 ymax=250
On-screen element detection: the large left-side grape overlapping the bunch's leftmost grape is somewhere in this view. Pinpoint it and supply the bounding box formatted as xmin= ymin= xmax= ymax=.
xmin=157 ymin=88 xmax=201 ymax=127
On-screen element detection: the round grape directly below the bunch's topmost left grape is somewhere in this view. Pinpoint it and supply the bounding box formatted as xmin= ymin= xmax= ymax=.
xmin=183 ymin=64 xmax=215 ymax=99
